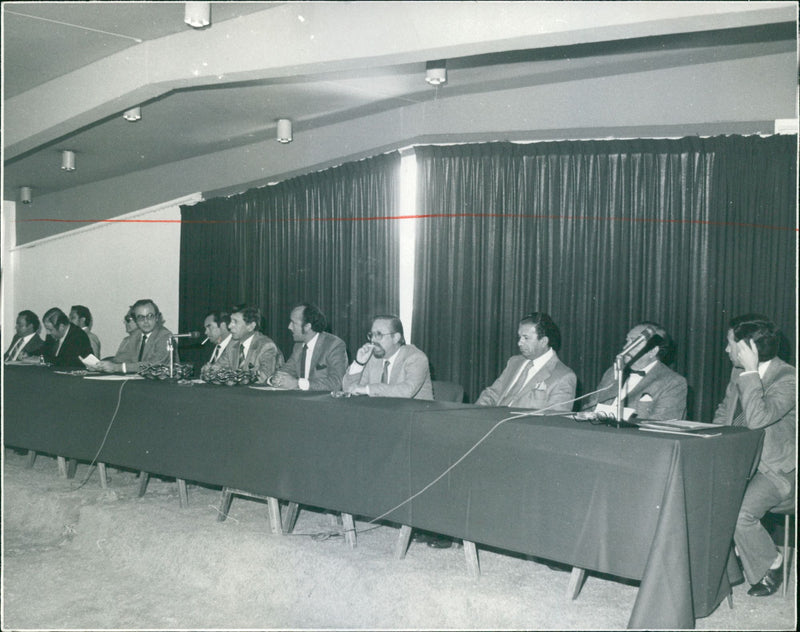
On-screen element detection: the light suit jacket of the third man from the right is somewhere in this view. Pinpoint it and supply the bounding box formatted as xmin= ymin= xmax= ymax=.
xmin=475 ymin=352 xmax=578 ymax=413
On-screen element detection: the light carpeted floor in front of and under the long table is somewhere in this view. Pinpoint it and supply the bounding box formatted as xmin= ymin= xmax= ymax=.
xmin=2 ymin=450 xmax=796 ymax=630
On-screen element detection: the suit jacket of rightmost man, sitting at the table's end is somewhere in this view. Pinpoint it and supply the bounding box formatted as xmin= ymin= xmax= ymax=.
xmin=714 ymin=358 xmax=797 ymax=493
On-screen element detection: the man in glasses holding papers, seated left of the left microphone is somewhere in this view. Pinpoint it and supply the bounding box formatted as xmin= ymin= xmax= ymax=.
xmin=95 ymin=298 xmax=172 ymax=373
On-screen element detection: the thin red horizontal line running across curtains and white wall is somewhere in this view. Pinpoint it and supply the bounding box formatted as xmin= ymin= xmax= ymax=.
xmin=16 ymin=213 xmax=799 ymax=232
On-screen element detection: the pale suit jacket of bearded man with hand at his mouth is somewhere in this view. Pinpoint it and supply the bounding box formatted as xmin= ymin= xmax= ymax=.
xmin=342 ymin=344 xmax=433 ymax=399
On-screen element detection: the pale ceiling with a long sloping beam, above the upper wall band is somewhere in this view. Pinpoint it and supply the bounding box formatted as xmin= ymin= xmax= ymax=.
xmin=2 ymin=2 xmax=796 ymax=200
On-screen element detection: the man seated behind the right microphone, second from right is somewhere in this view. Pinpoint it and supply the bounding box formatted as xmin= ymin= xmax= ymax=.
xmin=583 ymin=321 xmax=688 ymax=421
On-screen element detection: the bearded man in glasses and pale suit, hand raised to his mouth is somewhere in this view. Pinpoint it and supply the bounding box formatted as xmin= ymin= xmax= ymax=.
xmin=342 ymin=315 xmax=433 ymax=399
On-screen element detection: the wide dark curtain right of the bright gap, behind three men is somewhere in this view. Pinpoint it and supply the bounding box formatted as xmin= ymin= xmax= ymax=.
xmin=413 ymin=136 xmax=797 ymax=420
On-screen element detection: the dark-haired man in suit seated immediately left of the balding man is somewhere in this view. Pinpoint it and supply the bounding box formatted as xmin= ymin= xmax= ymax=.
xmin=217 ymin=305 xmax=283 ymax=383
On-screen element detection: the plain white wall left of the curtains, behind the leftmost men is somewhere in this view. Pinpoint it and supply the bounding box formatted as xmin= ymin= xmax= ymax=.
xmin=3 ymin=194 xmax=201 ymax=356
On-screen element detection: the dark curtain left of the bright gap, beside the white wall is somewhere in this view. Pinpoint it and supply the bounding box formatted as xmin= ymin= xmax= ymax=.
xmin=180 ymin=152 xmax=400 ymax=357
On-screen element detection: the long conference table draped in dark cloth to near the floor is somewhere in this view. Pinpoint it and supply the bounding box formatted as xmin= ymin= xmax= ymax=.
xmin=3 ymin=366 xmax=763 ymax=629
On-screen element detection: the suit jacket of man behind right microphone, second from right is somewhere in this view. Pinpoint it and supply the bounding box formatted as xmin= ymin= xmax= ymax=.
xmin=583 ymin=362 xmax=688 ymax=421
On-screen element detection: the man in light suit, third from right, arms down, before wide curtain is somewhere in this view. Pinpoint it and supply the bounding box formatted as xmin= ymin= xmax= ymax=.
xmin=475 ymin=312 xmax=578 ymax=413
